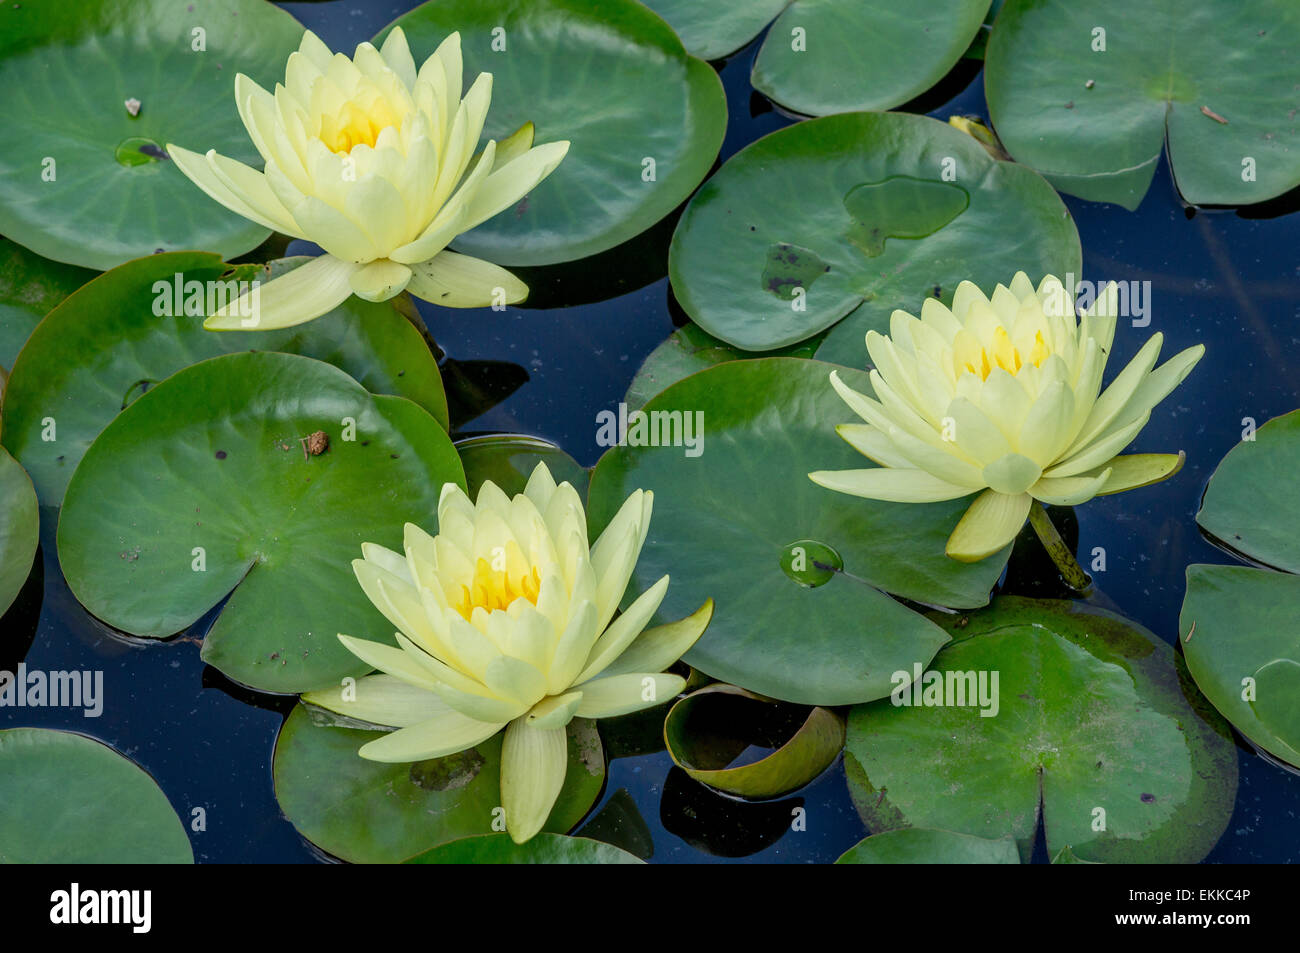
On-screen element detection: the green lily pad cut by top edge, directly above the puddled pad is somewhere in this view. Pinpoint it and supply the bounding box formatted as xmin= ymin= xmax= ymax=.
xmin=751 ymin=0 xmax=989 ymax=116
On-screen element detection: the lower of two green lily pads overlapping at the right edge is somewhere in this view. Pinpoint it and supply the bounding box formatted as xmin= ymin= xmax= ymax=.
xmin=1179 ymin=564 xmax=1300 ymax=764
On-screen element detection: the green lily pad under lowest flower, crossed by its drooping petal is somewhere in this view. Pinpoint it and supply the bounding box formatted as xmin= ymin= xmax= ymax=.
xmin=272 ymin=705 xmax=605 ymax=863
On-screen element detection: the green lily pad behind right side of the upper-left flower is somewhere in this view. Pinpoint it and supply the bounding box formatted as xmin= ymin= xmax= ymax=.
xmin=381 ymin=0 xmax=727 ymax=265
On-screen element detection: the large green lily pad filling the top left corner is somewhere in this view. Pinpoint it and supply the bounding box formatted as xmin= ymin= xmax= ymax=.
xmin=0 ymin=0 xmax=303 ymax=269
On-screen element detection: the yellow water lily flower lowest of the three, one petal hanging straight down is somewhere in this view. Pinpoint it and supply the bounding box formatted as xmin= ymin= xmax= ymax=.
xmin=303 ymin=463 xmax=712 ymax=844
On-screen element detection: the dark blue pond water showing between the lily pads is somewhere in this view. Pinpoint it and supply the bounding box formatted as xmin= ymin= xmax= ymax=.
xmin=0 ymin=0 xmax=1300 ymax=862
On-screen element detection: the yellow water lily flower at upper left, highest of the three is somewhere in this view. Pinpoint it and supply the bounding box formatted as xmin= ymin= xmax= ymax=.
xmin=166 ymin=27 xmax=569 ymax=330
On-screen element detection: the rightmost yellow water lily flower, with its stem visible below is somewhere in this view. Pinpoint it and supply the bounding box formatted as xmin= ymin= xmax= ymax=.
xmin=809 ymin=272 xmax=1205 ymax=562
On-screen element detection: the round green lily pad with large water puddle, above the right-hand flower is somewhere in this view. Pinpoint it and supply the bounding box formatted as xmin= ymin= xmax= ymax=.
xmin=668 ymin=113 xmax=1080 ymax=356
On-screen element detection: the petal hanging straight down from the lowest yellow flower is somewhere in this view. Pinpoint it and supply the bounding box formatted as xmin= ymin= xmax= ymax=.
xmin=501 ymin=718 xmax=568 ymax=844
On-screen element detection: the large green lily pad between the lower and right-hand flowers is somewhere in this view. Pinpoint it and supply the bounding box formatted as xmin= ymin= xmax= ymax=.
xmin=588 ymin=358 xmax=1006 ymax=706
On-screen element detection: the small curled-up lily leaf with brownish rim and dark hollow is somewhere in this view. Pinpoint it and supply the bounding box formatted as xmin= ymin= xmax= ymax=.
xmin=663 ymin=685 xmax=844 ymax=798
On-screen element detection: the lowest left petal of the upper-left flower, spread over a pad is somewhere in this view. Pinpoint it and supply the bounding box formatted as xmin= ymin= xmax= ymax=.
xmin=203 ymin=255 xmax=358 ymax=332
